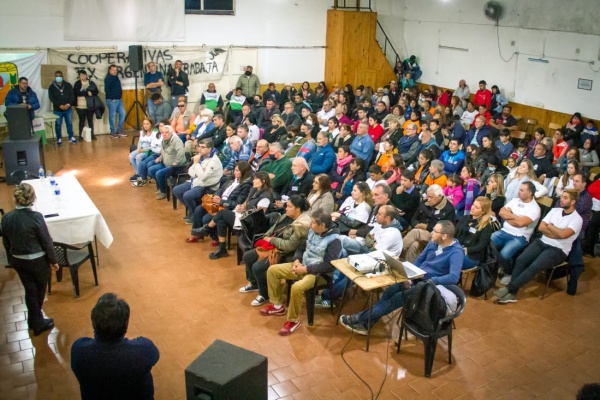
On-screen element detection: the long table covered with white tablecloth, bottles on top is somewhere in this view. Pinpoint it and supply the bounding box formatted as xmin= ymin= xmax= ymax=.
xmin=23 ymin=175 xmax=113 ymax=248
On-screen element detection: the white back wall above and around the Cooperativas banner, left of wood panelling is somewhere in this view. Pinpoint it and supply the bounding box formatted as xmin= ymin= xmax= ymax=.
xmin=0 ymin=0 xmax=333 ymax=82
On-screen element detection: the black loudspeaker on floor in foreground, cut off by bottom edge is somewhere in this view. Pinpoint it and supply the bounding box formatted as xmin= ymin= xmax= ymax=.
xmin=185 ymin=340 xmax=268 ymax=400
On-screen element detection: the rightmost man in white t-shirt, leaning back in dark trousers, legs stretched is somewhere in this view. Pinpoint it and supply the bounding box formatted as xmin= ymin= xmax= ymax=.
xmin=494 ymin=189 xmax=583 ymax=304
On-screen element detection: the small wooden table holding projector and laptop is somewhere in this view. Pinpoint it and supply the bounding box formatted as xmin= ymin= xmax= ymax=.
xmin=331 ymin=258 xmax=420 ymax=351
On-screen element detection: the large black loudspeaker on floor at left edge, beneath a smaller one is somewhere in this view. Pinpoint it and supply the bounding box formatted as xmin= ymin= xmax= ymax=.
xmin=2 ymin=136 xmax=46 ymax=185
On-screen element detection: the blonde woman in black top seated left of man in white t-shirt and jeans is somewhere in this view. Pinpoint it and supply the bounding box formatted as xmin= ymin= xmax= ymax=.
xmin=455 ymin=196 xmax=492 ymax=269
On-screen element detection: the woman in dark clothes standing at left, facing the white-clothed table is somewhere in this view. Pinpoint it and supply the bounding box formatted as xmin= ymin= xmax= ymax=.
xmin=2 ymin=183 xmax=59 ymax=336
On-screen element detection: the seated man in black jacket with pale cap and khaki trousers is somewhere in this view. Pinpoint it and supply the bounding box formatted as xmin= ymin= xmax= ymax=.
xmin=403 ymin=184 xmax=456 ymax=262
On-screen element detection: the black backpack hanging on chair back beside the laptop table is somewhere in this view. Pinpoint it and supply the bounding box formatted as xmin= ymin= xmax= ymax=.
xmin=402 ymin=280 xmax=446 ymax=333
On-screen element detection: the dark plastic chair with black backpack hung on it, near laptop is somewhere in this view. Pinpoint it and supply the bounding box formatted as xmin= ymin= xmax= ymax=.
xmin=396 ymin=285 xmax=467 ymax=378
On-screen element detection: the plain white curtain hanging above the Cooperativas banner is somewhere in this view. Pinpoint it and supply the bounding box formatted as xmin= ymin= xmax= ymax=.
xmin=64 ymin=0 xmax=185 ymax=42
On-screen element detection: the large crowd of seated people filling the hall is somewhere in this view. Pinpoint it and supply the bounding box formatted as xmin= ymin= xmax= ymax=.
xmin=130 ymin=73 xmax=600 ymax=335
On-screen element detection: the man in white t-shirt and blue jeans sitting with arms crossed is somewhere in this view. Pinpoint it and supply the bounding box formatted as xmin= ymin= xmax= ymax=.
xmin=492 ymin=182 xmax=541 ymax=284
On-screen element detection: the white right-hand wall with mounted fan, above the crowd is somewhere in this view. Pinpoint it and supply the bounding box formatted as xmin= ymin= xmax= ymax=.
xmin=377 ymin=0 xmax=600 ymax=118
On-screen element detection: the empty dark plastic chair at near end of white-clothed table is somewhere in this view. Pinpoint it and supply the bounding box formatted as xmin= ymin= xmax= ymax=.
xmin=48 ymin=242 xmax=98 ymax=298
